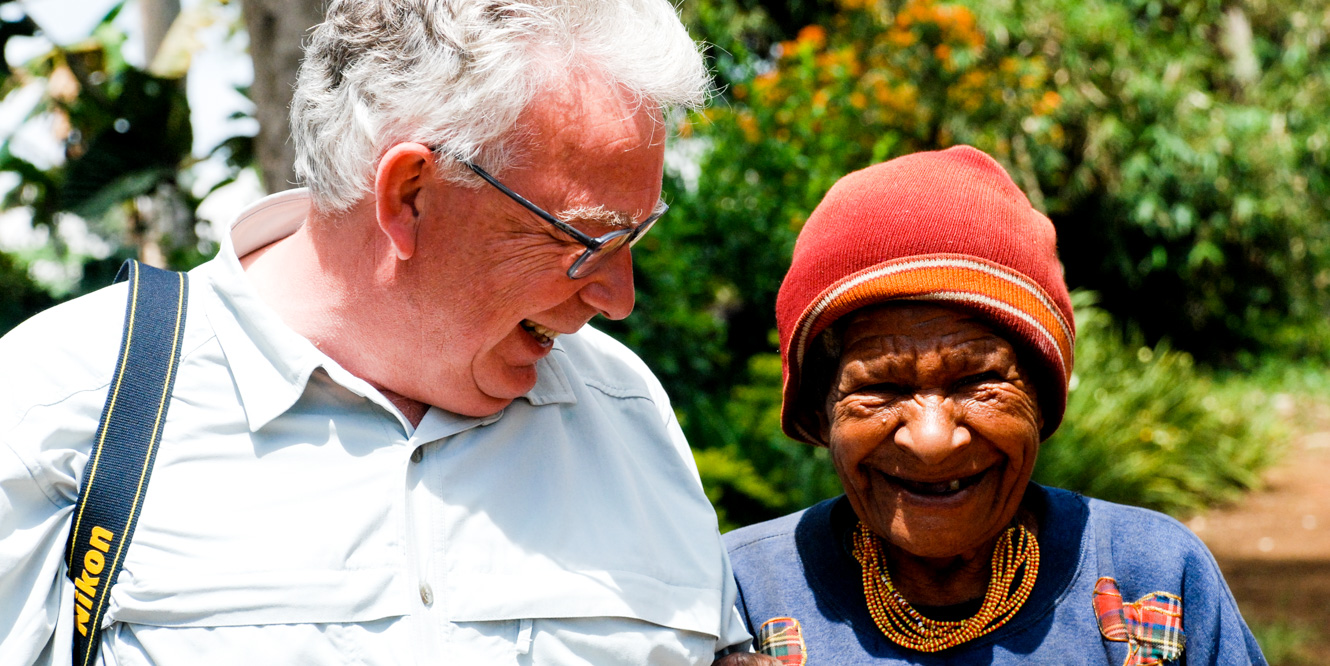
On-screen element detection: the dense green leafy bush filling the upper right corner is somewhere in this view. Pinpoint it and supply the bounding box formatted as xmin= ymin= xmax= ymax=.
xmin=994 ymin=0 xmax=1330 ymax=360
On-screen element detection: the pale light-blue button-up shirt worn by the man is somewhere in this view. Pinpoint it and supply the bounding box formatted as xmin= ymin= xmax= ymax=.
xmin=0 ymin=190 xmax=747 ymax=666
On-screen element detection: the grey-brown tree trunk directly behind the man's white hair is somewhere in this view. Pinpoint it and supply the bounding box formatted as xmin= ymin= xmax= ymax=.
xmin=241 ymin=0 xmax=323 ymax=193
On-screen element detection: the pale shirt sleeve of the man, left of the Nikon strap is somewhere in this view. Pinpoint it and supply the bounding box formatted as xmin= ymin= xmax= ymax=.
xmin=0 ymin=290 xmax=124 ymax=665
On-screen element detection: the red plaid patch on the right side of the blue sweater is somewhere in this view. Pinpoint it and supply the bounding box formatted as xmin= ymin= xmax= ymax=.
xmin=1093 ymin=577 xmax=1186 ymax=666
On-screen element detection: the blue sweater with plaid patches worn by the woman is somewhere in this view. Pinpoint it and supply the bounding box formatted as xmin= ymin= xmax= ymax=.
xmin=725 ymin=484 xmax=1265 ymax=666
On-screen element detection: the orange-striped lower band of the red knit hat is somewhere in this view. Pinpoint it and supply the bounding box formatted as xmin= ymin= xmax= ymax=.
xmin=783 ymin=254 xmax=1075 ymax=441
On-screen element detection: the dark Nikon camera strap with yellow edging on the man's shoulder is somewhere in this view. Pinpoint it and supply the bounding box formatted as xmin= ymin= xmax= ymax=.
xmin=65 ymin=261 xmax=189 ymax=666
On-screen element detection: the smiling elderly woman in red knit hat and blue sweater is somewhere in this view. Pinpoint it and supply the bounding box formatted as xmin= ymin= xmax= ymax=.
xmin=726 ymin=146 xmax=1265 ymax=666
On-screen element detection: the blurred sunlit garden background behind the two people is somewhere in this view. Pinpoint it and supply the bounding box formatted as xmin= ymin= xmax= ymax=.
xmin=0 ymin=0 xmax=1330 ymax=665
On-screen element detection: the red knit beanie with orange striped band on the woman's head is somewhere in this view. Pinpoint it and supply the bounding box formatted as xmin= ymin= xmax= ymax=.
xmin=775 ymin=146 xmax=1076 ymax=444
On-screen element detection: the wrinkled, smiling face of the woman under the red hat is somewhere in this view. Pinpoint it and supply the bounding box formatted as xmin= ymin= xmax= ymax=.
xmin=821 ymin=303 xmax=1041 ymax=558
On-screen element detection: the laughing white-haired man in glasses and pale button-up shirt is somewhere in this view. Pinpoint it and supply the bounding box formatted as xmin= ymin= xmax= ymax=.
xmin=0 ymin=0 xmax=753 ymax=665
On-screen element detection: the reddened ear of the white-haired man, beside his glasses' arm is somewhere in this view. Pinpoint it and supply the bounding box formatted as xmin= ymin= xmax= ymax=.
xmin=374 ymin=144 xmax=434 ymax=261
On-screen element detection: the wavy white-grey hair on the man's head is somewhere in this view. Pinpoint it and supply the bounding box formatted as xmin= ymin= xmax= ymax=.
xmin=291 ymin=0 xmax=710 ymax=211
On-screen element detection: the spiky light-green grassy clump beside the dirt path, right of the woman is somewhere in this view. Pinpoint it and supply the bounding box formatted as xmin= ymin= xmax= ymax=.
xmin=1035 ymin=292 xmax=1287 ymax=514
